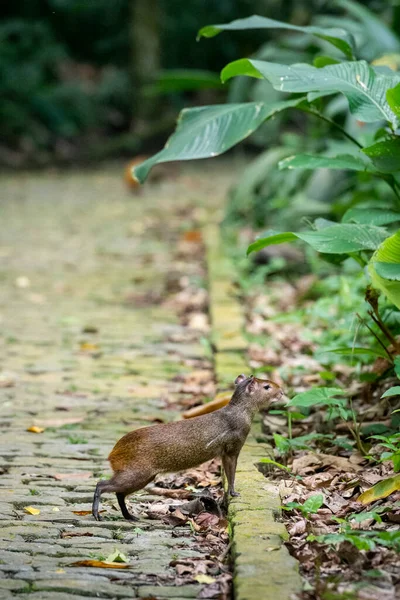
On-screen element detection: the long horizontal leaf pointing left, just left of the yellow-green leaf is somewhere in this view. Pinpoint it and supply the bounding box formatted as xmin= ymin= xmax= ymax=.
xmin=247 ymin=223 xmax=387 ymax=254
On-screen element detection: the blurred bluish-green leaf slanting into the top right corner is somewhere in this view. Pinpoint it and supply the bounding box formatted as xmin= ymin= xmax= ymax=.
xmin=336 ymin=0 xmax=400 ymax=54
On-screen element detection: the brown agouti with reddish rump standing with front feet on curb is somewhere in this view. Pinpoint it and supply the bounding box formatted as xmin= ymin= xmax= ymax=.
xmin=92 ymin=375 xmax=283 ymax=521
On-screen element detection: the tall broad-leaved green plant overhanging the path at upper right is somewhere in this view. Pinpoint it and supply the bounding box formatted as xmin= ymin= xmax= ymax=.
xmin=134 ymin=5 xmax=400 ymax=314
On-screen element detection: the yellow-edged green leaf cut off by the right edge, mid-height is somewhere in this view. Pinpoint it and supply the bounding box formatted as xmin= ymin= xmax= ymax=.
xmin=368 ymin=230 xmax=400 ymax=308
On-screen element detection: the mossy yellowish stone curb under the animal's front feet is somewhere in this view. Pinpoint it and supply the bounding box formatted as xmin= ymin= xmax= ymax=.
xmin=204 ymin=224 xmax=301 ymax=600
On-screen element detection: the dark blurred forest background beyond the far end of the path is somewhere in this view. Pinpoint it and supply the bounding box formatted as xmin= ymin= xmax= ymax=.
xmin=0 ymin=0 xmax=394 ymax=168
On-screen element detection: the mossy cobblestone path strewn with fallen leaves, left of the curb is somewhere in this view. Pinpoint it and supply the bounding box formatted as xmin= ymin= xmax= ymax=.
xmin=0 ymin=164 xmax=230 ymax=600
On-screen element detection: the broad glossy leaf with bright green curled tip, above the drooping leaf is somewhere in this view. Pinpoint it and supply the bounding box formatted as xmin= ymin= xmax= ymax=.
xmin=221 ymin=58 xmax=400 ymax=128
